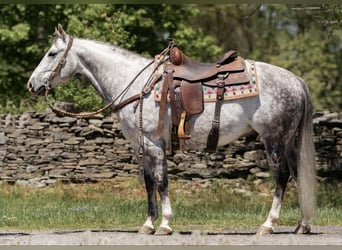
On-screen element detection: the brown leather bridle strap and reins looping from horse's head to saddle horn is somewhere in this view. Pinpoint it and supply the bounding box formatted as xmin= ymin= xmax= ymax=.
xmin=45 ymin=37 xmax=173 ymax=118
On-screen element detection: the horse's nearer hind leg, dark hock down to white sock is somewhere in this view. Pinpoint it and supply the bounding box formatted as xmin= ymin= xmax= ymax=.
xmin=257 ymin=141 xmax=290 ymax=235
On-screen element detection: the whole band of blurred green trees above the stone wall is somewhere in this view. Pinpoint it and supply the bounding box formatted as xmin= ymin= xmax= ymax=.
xmin=0 ymin=4 xmax=342 ymax=112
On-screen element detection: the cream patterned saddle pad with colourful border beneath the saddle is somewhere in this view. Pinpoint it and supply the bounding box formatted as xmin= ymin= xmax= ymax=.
xmin=154 ymin=61 xmax=259 ymax=102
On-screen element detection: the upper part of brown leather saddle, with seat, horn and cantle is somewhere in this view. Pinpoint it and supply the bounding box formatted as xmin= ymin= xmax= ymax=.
xmin=170 ymin=47 xmax=249 ymax=85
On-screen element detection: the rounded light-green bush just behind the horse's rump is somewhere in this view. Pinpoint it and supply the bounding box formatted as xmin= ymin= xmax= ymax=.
xmin=270 ymin=30 xmax=341 ymax=110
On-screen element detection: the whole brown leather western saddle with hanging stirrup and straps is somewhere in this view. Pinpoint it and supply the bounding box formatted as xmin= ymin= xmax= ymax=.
xmin=157 ymin=42 xmax=250 ymax=152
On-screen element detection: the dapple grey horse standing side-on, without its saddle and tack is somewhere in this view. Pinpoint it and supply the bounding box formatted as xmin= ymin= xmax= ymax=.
xmin=27 ymin=25 xmax=316 ymax=234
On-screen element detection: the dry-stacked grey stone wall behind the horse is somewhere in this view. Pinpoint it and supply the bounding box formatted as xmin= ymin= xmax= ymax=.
xmin=0 ymin=112 xmax=342 ymax=186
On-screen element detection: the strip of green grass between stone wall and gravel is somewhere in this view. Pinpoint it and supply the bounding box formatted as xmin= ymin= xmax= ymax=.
xmin=0 ymin=178 xmax=342 ymax=231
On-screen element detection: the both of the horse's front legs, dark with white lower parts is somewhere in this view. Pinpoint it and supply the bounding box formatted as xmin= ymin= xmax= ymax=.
xmin=139 ymin=138 xmax=172 ymax=235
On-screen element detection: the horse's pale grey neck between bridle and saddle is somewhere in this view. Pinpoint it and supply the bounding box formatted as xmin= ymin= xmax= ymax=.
xmin=76 ymin=39 xmax=149 ymax=101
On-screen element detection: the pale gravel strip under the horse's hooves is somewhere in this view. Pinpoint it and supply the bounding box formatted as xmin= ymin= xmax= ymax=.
xmin=0 ymin=226 xmax=342 ymax=245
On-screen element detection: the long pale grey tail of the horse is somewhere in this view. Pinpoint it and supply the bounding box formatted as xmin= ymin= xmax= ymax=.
xmin=298 ymin=78 xmax=317 ymax=220
